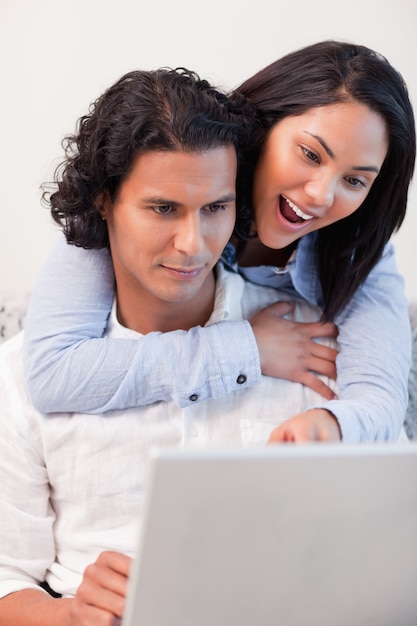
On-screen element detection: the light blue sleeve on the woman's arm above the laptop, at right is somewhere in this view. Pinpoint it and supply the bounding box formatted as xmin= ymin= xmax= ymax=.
xmin=310 ymin=243 xmax=411 ymax=443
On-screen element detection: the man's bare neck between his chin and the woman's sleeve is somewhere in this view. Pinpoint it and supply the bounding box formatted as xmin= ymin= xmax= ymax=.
xmin=116 ymin=272 xmax=216 ymax=335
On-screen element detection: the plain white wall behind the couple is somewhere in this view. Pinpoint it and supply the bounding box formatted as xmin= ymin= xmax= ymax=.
xmin=0 ymin=0 xmax=417 ymax=299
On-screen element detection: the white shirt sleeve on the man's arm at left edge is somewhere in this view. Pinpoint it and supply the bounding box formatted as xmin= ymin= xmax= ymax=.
xmin=0 ymin=335 xmax=55 ymax=597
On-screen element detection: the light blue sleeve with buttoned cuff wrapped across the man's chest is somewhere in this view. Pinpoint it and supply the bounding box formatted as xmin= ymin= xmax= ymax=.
xmin=24 ymin=238 xmax=261 ymax=413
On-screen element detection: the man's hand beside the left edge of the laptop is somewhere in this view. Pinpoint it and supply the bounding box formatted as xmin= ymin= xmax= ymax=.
xmin=69 ymin=552 xmax=132 ymax=626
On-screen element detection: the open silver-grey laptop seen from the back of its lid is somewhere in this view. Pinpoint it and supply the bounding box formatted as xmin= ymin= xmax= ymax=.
xmin=123 ymin=443 xmax=417 ymax=626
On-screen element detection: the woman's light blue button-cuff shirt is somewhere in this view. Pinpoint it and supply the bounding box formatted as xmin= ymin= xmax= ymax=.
xmin=25 ymin=233 xmax=411 ymax=442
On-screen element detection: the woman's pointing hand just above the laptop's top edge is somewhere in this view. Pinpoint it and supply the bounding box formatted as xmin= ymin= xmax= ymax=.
xmin=268 ymin=409 xmax=342 ymax=443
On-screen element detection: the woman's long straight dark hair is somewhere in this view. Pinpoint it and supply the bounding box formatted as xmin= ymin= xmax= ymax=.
xmin=238 ymin=41 xmax=416 ymax=319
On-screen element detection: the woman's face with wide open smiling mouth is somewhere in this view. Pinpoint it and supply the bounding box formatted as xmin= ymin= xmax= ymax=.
xmin=253 ymin=102 xmax=388 ymax=249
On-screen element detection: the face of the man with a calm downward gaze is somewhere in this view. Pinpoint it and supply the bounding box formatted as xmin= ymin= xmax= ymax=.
xmin=102 ymin=146 xmax=237 ymax=332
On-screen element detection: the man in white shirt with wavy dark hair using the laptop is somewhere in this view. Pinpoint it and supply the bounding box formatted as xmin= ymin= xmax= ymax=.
xmin=0 ymin=70 xmax=338 ymax=626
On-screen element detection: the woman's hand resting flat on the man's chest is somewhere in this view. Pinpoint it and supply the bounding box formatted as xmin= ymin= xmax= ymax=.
xmin=249 ymin=302 xmax=338 ymax=400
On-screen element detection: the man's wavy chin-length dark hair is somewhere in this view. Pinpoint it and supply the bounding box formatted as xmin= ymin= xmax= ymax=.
xmin=43 ymin=68 xmax=257 ymax=248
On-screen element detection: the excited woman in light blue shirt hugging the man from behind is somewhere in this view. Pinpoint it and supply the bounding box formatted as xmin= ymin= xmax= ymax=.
xmin=22 ymin=41 xmax=415 ymax=442
